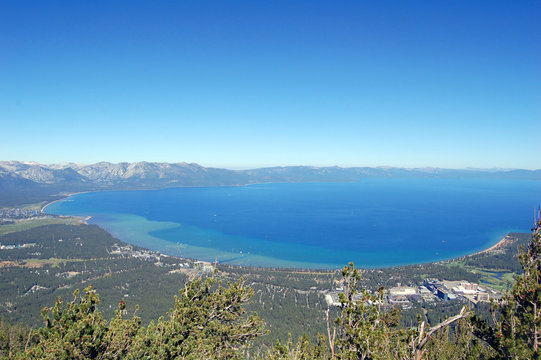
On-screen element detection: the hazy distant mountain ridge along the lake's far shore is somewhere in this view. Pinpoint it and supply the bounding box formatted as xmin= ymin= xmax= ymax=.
xmin=0 ymin=161 xmax=541 ymax=206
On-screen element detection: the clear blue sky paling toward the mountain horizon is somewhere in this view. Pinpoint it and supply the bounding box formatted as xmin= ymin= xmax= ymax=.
xmin=0 ymin=0 xmax=541 ymax=169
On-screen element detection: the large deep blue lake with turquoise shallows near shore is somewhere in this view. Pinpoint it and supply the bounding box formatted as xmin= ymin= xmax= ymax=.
xmin=45 ymin=179 xmax=541 ymax=268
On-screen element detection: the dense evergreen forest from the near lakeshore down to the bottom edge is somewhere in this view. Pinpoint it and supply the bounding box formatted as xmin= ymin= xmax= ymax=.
xmin=0 ymin=218 xmax=540 ymax=359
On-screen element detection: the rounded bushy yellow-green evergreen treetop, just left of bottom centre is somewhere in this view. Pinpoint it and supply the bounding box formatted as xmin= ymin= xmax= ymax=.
xmin=127 ymin=278 xmax=265 ymax=359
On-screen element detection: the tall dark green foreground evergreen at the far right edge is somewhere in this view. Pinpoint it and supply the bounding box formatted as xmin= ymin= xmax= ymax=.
xmin=472 ymin=215 xmax=541 ymax=359
